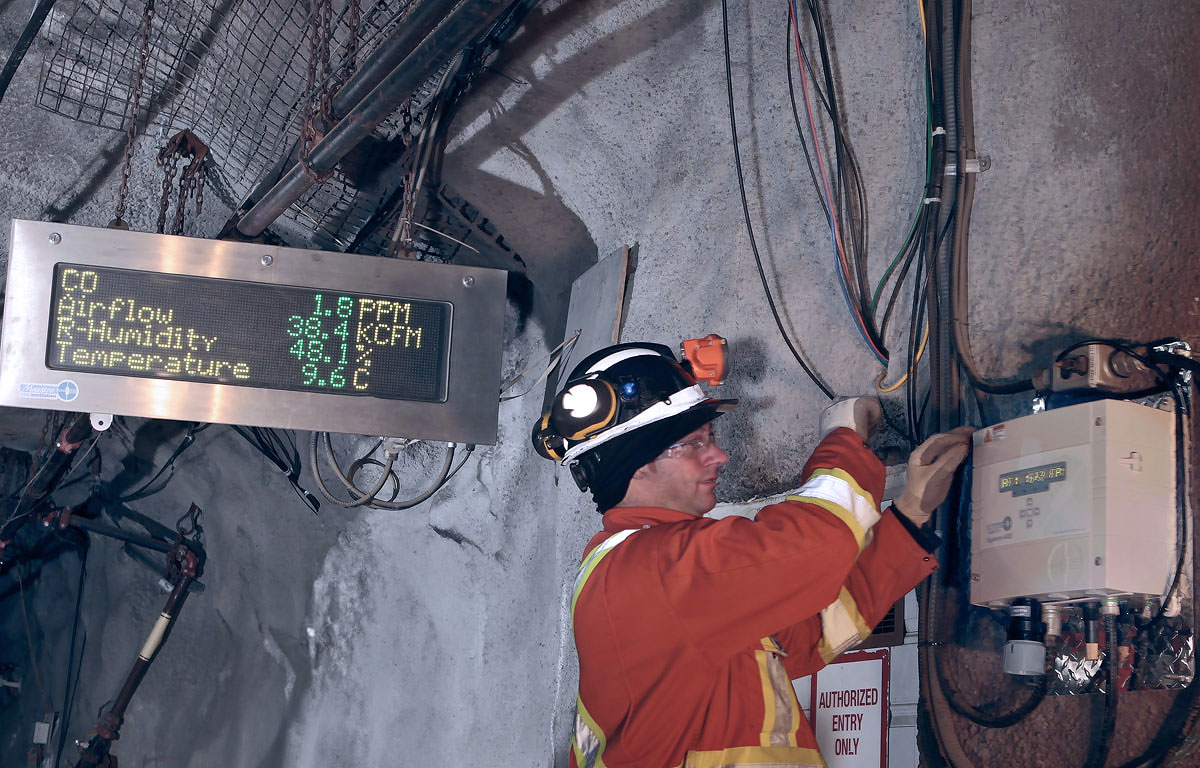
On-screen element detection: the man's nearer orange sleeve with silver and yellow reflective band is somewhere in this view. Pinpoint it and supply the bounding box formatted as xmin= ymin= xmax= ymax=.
xmin=657 ymin=428 xmax=907 ymax=659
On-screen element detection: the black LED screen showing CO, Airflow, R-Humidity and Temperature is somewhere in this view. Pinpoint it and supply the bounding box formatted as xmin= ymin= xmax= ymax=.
xmin=46 ymin=263 xmax=452 ymax=402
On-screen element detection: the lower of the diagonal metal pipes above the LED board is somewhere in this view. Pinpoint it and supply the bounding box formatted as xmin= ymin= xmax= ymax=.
xmin=238 ymin=0 xmax=510 ymax=238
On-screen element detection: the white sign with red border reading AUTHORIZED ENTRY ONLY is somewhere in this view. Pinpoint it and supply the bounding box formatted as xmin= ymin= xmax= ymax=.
xmin=809 ymin=648 xmax=890 ymax=768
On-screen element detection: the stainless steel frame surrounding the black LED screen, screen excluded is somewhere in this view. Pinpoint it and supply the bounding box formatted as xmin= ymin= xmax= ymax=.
xmin=0 ymin=220 xmax=506 ymax=445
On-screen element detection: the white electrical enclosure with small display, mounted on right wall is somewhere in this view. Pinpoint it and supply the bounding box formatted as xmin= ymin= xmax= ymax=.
xmin=971 ymin=400 xmax=1177 ymax=605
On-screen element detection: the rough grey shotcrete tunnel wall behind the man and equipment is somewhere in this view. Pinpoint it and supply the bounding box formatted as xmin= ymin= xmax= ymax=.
xmin=0 ymin=0 xmax=1200 ymax=768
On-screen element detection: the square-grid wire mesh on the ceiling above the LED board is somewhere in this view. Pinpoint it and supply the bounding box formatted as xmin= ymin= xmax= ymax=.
xmin=37 ymin=0 xmax=424 ymax=247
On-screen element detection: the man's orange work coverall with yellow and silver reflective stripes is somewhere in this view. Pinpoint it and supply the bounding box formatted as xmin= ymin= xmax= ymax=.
xmin=570 ymin=428 xmax=936 ymax=768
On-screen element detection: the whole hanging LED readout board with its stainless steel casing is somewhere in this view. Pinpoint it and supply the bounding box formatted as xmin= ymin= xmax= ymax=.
xmin=0 ymin=220 xmax=506 ymax=444
